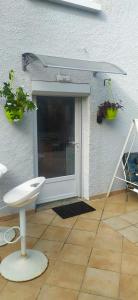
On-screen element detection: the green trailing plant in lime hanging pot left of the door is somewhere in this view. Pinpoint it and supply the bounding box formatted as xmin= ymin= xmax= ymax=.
xmin=0 ymin=70 xmax=36 ymax=122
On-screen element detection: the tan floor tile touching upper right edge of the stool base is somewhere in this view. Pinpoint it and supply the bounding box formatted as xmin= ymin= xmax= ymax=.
xmin=34 ymin=239 xmax=63 ymax=259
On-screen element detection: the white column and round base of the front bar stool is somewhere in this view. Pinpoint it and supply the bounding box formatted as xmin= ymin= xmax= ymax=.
xmin=0 ymin=208 xmax=48 ymax=281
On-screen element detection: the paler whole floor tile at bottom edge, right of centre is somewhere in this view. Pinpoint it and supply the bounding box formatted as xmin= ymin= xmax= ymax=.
xmin=82 ymin=268 xmax=120 ymax=298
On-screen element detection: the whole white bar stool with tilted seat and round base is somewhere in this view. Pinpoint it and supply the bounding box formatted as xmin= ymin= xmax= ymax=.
xmin=0 ymin=177 xmax=48 ymax=281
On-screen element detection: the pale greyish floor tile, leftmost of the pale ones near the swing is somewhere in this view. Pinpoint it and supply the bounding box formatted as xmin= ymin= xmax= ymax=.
xmin=103 ymin=216 xmax=130 ymax=230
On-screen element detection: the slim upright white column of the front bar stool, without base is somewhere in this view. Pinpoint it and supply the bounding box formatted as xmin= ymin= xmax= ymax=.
xmin=19 ymin=208 xmax=27 ymax=256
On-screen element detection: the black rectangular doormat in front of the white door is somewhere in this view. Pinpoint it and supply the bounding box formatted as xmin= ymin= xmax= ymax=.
xmin=53 ymin=201 xmax=96 ymax=219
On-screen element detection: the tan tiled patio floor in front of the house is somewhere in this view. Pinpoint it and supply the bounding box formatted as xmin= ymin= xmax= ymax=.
xmin=0 ymin=193 xmax=138 ymax=300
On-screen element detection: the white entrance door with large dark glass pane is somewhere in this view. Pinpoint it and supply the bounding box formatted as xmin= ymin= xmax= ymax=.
xmin=37 ymin=96 xmax=81 ymax=204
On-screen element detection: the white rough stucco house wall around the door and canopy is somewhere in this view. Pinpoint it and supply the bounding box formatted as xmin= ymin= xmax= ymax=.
xmin=0 ymin=0 xmax=138 ymax=210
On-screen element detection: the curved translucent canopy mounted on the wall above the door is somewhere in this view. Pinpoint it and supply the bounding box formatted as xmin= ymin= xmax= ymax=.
xmin=22 ymin=53 xmax=127 ymax=75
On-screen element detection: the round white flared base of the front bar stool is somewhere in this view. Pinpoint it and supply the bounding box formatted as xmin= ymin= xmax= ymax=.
xmin=0 ymin=250 xmax=48 ymax=282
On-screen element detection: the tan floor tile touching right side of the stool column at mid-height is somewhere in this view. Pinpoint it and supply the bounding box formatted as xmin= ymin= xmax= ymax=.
xmin=27 ymin=223 xmax=47 ymax=238
